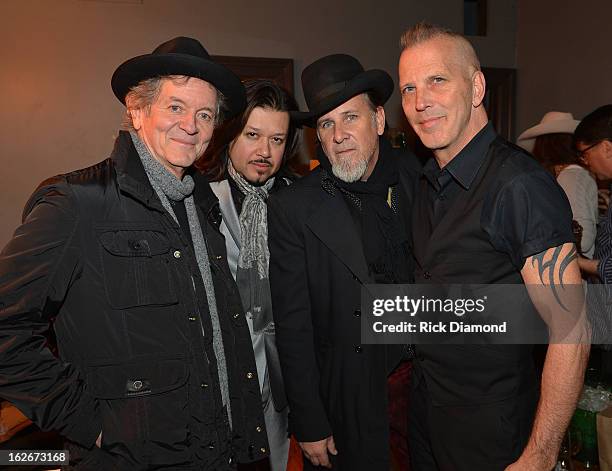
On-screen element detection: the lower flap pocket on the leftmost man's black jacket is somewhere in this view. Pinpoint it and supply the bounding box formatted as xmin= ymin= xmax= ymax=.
xmin=87 ymin=357 xmax=191 ymax=462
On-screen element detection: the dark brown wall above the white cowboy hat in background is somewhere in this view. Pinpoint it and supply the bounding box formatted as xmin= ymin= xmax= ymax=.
xmin=516 ymin=0 xmax=612 ymax=138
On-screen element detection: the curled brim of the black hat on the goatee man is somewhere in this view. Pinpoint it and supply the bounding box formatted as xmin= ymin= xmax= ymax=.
xmin=292 ymin=69 xmax=393 ymax=128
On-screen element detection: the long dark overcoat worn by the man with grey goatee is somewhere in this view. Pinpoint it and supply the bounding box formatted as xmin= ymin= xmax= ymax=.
xmin=268 ymin=144 xmax=418 ymax=471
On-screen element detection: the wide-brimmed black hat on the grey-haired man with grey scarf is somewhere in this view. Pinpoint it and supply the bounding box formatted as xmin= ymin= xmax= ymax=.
xmin=111 ymin=36 xmax=246 ymax=117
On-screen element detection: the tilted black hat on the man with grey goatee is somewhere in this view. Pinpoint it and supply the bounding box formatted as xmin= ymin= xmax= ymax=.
xmin=292 ymin=54 xmax=393 ymax=127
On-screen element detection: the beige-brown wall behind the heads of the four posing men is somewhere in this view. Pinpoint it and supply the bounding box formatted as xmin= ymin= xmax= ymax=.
xmin=0 ymin=0 xmax=516 ymax=247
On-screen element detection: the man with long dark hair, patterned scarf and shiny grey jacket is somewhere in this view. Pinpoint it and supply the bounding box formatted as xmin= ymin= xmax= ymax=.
xmin=196 ymin=80 xmax=299 ymax=471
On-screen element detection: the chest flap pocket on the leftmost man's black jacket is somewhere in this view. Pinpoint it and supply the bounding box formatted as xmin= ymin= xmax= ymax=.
xmin=98 ymin=228 xmax=178 ymax=309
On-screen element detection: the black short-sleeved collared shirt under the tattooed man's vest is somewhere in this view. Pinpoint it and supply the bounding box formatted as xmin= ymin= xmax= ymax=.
xmin=423 ymin=122 xmax=573 ymax=269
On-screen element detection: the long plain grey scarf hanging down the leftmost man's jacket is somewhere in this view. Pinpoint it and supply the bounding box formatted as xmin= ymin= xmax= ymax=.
xmin=130 ymin=131 xmax=232 ymax=426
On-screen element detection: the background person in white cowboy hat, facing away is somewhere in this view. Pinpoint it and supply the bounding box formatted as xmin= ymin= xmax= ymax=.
xmin=517 ymin=111 xmax=598 ymax=258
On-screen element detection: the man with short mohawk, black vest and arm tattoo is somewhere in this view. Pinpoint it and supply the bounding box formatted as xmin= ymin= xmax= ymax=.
xmin=399 ymin=24 xmax=589 ymax=471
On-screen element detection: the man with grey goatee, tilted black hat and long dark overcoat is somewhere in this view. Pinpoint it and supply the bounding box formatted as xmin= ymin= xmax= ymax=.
xmin=268 ymin=54 xmax=418 ymax=471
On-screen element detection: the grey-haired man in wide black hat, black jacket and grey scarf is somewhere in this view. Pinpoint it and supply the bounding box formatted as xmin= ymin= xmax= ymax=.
xmin=0 ymin=37 xmax=267 ymax=471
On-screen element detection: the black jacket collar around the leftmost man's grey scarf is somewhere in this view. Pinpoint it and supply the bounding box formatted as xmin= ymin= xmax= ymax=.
xmin=111 ymin=131 xmax=218 ymax=215
